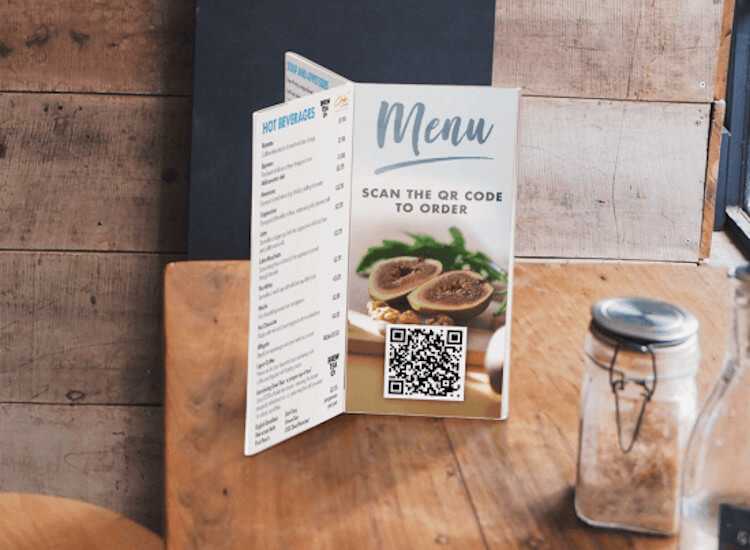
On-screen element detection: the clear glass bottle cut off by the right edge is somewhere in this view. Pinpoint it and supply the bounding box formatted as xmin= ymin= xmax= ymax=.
xmin=679 ymin=265 xmax=750 ymax=550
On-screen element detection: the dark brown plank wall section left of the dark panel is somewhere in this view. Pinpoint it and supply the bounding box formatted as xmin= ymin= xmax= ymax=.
xmin=0 ymin=0 xmax=194 ymax=531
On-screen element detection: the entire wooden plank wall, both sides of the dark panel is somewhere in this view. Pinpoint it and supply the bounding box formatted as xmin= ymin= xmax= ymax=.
xmin=0 ymin=0 xmax=732 ymax=530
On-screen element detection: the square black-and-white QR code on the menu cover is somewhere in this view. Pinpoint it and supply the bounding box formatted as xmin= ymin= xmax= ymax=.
xmin=383 ymin=325 xmax=466 ymax=401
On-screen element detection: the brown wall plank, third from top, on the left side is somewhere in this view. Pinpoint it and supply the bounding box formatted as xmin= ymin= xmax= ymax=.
xmin=0 ymin=252 xmax=176 ymax=406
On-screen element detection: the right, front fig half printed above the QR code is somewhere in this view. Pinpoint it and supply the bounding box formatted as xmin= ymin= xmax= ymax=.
xmin=407 ymin=271 xmax=495 ymax=319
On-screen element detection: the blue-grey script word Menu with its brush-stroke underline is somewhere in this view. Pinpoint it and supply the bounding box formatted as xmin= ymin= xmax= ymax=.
xmin=375 ymin=101 xmax=495 ymax=174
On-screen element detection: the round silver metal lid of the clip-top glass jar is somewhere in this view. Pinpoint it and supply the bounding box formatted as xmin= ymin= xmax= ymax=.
xmin=591 ymin=297 xmax=700 ymax=346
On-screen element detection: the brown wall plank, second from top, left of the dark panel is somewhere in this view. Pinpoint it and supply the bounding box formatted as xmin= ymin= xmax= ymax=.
xmin=0 ymin=94 xmax=190 ymax=252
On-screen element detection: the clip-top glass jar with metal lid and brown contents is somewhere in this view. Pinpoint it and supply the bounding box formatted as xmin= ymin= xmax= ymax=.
xmin=575 ymin=298 xmax=700 ymax=535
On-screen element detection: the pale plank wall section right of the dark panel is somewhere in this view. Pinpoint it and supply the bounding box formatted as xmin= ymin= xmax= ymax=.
xmin=500 ymin=0 xmax=722 ymax=261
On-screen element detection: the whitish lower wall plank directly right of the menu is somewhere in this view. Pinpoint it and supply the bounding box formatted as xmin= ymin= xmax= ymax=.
xmin=516 ymin=98 xmax=709 ymax=261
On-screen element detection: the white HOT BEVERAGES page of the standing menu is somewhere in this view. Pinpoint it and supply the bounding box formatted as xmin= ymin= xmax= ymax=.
xmin=245 ymin=84 xmax=353 ymax=455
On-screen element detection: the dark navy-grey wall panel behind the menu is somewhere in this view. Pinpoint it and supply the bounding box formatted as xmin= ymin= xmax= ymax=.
xmin=188 ymin=0 xmax=495 ymax=259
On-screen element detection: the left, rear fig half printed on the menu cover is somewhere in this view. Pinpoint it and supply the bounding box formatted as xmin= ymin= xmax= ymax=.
xmin=367 ymin=256 xmax=443 ymax=302
